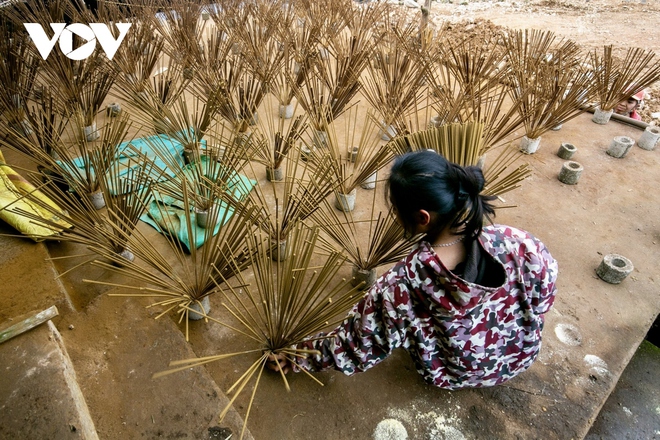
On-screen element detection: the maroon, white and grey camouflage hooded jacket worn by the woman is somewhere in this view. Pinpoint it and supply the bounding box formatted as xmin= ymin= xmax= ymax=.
xmin=295 ymin=225 xmax=557 ymax=389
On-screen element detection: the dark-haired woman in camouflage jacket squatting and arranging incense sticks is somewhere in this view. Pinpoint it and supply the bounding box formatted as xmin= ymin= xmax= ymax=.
xmin=269 ymin=151 xmax=558 ymax=389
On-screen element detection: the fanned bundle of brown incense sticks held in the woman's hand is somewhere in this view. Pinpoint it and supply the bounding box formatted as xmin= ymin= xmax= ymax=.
xmin=154 ymin=223 xmax=359 ymax=438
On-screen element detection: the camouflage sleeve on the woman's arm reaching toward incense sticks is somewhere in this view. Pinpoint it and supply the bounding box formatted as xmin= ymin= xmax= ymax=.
xmin=294 ymin=280 xmax=409 ymax=375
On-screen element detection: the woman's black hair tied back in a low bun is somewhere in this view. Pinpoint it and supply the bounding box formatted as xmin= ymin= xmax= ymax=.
xmin=388 ymin=150 xmax=495 ymax=239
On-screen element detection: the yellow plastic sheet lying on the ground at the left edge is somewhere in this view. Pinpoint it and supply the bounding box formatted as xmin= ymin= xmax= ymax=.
xmin=0 ymin=152 xmax=71 ymax=241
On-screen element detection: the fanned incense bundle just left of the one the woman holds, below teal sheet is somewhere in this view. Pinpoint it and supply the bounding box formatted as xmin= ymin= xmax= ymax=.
xmin=84 ymin=175 xmax=257 ymax=340
